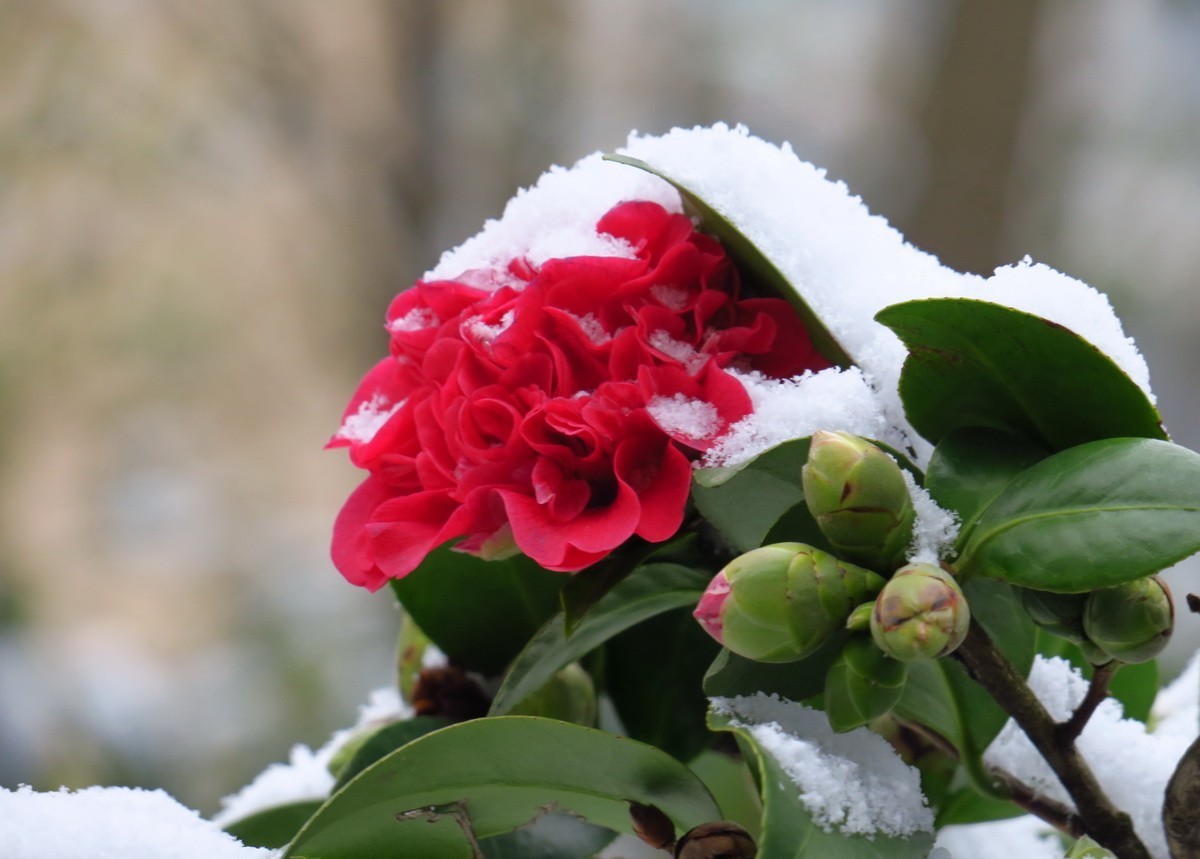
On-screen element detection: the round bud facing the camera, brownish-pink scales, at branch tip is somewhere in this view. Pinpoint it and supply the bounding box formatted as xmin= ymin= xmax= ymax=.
xmin=871 ymin=564 xmax=971 ymax=662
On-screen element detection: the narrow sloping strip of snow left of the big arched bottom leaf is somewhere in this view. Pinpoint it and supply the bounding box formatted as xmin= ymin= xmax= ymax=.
xmin=212 ymin=687 xmax=413 ymax=827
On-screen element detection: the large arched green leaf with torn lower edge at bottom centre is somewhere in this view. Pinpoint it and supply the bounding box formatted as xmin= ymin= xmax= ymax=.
xmin=283 ymin=716 xmax=719 ymax=859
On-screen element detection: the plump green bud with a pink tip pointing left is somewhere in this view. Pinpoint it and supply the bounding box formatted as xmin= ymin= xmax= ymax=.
xmin=695 ymin=542 xmax=883 ymax=662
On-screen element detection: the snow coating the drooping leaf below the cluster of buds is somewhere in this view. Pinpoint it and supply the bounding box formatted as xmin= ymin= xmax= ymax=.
xmin=710 ymin=693 xmax=934 ymax=836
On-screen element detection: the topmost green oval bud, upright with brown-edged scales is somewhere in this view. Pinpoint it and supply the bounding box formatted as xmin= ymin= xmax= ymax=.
xmin=800 ymin=431 xmax=916 ymax=569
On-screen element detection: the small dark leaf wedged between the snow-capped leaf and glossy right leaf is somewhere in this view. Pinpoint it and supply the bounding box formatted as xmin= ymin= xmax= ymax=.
xmin=925 ymin=428 xmax=1050 ymax=545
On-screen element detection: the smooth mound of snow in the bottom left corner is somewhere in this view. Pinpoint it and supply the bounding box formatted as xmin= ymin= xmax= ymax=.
xmin=0 ymin=786 xmax=274 ymax=859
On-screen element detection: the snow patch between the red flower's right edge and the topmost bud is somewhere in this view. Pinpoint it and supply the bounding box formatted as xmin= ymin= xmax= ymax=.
xmin=703 ymin=368 xmax=904 ymax=465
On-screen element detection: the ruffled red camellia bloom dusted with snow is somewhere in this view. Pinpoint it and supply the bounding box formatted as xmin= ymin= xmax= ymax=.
xmin=329 ymin=203 xmax=829 ymax=590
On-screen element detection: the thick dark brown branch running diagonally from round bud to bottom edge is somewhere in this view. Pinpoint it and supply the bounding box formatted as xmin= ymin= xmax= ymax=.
xmin=955 ymin=623 xmax=1151 ymax=859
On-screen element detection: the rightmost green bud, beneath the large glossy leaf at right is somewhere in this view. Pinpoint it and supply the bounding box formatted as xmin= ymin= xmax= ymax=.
xmin=1084 ymin=576 xmax=1175 ymax=662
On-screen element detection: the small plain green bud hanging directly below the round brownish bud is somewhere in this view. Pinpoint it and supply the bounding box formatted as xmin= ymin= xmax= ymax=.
xmin=824 ymin=635 xmax=908 ymax=732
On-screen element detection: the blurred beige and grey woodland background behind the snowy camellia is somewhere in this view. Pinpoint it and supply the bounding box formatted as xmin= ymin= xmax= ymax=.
xmin=0 ymin=0 xmax=1200 ymax=812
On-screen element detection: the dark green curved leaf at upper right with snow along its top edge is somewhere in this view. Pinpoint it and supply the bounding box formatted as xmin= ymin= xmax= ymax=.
xmin=875 ymin=299 xmax=1166 ymax=450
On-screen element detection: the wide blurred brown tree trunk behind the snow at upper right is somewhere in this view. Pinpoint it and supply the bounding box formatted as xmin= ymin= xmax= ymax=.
xmin=902 ymin=0 xmax=1040 ymax=274
